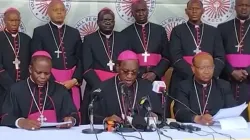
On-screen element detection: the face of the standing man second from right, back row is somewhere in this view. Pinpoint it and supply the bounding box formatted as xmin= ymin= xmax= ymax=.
xmin=185 ymin=2 xmax=204 ymax=21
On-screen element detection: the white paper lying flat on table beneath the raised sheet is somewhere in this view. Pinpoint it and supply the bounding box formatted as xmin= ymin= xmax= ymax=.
xmin=218 ymin=116 xmax=248 ymax=130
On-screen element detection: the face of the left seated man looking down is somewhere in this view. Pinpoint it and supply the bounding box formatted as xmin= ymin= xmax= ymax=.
xmin=29 ymin=58 xmax=52 ymax=86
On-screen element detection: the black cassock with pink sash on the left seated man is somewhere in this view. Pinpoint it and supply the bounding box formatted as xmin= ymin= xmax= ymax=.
xmin=1 ymin=78 xmax=79 ymax=127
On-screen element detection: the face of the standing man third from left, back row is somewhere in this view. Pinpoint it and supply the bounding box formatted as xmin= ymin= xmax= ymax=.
xmin=97 ymin=13 xmax=115 ymax=32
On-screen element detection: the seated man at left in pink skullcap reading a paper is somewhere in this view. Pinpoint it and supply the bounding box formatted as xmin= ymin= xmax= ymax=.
xmin=1 ymin=51 xmax=79 ymax=130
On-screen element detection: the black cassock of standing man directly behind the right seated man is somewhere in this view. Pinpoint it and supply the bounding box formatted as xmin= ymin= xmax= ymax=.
xmin=169 ymin=22 xmax=225 ymax=97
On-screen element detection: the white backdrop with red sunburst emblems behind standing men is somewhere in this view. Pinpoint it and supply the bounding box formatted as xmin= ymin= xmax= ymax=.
xmin=0 ymin=0 xmax=235 ymax=40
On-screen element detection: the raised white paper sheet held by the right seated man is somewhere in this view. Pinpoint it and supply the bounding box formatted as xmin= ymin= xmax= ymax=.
xmin=213 ymin=103 xmax=247 ymax=121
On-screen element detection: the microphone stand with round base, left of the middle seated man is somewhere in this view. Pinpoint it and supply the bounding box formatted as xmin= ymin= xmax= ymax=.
xmin=82 ymin=96 xmax=103 ymax=134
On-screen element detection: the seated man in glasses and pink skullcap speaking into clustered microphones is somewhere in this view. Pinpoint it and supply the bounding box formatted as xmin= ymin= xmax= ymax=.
xmin=94 ymin=50 xmax=162 ymax=123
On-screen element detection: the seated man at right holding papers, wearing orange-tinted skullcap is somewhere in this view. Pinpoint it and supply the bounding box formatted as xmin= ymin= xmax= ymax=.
xmin=174 ymin=52 xmax=236 ymax=125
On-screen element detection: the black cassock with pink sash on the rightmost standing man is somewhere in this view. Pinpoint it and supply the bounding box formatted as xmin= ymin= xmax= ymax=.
xmin=218 ymin=18 xmax=250 ymax=118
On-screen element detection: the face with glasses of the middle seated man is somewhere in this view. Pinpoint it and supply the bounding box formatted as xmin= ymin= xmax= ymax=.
xmin=116 ymin=60 xmax=139 ymax=86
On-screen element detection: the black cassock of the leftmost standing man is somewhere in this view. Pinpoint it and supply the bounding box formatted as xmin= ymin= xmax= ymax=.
xmin=0 ymin=30 xmax=31 ymax=114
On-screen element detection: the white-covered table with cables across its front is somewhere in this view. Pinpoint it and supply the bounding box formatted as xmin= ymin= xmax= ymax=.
xmin=0 ymin=123 xmax=250 ymax=140
